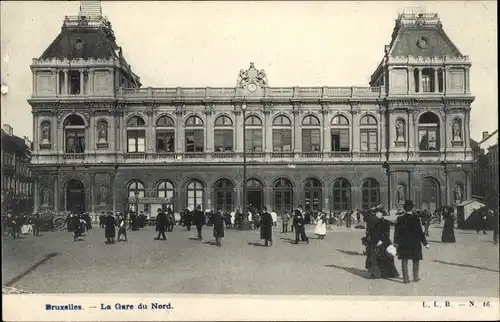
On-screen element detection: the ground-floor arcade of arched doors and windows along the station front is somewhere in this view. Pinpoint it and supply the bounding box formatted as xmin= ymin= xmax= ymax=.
xmin=34 ymin=164 xmax=471 ymax=213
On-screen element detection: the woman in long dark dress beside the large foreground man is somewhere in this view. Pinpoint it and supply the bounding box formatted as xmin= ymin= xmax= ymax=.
xmin=365 ymin=209 xmax=399 ymax=279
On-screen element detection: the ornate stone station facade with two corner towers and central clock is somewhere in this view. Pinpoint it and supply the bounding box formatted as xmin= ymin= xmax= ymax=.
xmin=29 ymin=10 xmax=474 ymax=212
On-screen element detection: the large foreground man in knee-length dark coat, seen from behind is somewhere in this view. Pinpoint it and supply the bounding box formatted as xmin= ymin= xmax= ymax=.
xmin=394 ymin=200 xmax=429 ymax=283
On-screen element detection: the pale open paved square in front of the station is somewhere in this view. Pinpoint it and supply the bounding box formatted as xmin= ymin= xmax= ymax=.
xmin=2 ymin=226 xmax=499 ymax=297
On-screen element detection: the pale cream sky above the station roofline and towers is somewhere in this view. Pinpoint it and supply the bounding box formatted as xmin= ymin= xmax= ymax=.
xmin=0 ymin=1 xmax=498 ymax=140
